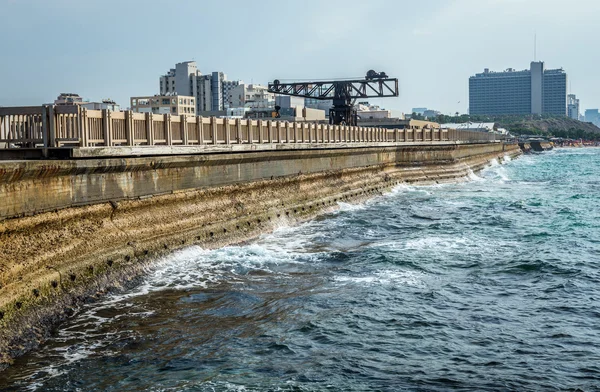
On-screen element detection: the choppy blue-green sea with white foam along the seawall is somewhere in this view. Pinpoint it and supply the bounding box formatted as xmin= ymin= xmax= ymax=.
xmin=0 ymin=149 xmax=600 ymax=391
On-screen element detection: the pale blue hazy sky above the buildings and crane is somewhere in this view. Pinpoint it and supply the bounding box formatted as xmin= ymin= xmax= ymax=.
xmin=0 ymin=0 xmax=600 ymax=114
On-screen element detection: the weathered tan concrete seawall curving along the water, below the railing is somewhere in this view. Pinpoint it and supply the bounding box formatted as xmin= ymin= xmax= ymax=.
xmin=0 ymin=143 xmax=521 ymax=366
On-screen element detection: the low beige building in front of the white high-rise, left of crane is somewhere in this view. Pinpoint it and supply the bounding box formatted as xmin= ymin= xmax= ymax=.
xmin=130 ymin=95 xmax=196 ymax=116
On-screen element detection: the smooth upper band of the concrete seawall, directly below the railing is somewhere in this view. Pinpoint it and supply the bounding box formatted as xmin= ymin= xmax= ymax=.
xmin=0 ymin=143 xmax=503 ymax=219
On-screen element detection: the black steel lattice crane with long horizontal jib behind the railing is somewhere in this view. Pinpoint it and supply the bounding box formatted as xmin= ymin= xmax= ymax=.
xmin=269 ymin=70 xmax=398 ymax=125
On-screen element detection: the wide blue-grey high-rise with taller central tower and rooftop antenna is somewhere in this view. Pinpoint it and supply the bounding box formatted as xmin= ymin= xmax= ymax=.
xmin=469 ymin=61 xmax=567 ymax=116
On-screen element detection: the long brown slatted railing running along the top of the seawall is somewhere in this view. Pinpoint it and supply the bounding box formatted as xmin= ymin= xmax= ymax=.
xmin=0 ymin=106 xmax=498 ymax=149
